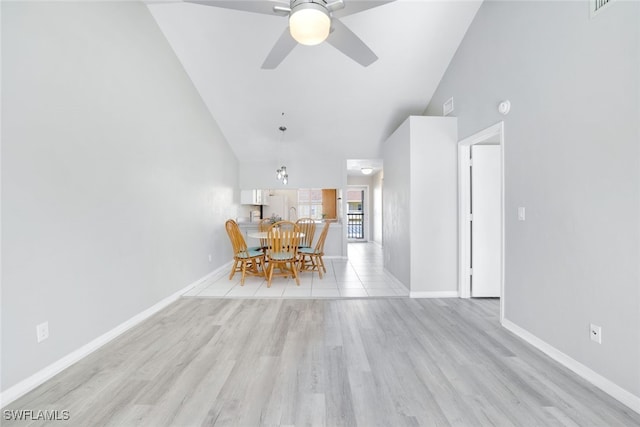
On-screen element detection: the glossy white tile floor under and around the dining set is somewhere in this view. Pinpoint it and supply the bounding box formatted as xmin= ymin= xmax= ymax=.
xmin=184 ymin=243 xmax=409 ymax=298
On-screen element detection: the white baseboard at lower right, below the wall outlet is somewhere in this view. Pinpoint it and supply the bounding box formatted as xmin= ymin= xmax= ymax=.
xmin=502 ymin=319 xmax=640 ymax=414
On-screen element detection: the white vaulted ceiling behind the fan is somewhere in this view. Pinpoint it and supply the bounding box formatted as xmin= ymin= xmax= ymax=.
xmin=147 ymin=0 xmax=481 ymax=169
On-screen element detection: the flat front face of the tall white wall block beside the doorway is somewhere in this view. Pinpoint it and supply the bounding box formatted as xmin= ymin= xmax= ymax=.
xmin=409 ymin=116 xmax=458 ymax=296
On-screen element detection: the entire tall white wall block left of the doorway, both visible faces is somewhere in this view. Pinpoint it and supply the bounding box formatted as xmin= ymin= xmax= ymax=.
xmin=382 ymin=116 xmax=458 ymax=297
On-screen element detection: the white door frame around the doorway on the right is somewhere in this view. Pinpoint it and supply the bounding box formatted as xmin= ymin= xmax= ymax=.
xmin=458 ymin=121 xmax=505 ymax=321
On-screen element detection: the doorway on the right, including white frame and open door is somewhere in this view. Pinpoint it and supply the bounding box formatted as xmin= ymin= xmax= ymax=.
xmin=458 ymin=122 xmax=504 ymax=319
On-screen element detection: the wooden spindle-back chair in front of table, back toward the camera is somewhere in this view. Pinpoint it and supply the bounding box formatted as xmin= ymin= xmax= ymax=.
xmin=266 ymin=221 xmax=300 ymax=288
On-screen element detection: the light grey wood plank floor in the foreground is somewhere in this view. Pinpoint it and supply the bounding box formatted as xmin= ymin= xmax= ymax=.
xmin=2 ymin=298 xmax=640 ymax=427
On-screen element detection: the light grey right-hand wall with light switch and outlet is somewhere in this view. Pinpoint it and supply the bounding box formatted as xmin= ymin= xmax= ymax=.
xmin=426 ymin=1 xmax=640 ymax=402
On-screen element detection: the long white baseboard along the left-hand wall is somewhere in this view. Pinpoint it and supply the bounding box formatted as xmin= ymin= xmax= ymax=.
xmin=0 ymin=264 xmax=229 ymax=408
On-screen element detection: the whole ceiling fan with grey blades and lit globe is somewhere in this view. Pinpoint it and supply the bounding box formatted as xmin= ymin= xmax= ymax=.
xmin=185 ymin=0 xmax=395 ymax=70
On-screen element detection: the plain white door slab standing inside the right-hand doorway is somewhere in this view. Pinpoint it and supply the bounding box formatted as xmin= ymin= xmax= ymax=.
xmin=471 ymin=145 xmax=502 ymax=297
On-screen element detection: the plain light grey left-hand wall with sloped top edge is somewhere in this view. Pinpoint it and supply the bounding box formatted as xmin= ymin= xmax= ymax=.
xmin=1 ymin=2 xmax=238 ymax=391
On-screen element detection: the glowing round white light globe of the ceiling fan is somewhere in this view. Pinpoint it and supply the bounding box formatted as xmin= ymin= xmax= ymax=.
xmin=289 ymin=3 xmax=331 ymax=46
